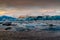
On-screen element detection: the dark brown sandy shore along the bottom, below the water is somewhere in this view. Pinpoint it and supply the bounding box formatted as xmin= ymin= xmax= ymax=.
xmin=0 ymin=31 xmax=60 ymax=40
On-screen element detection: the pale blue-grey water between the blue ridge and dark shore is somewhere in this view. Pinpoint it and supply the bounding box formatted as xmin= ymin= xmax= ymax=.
xmin=0 ymin=20 xmax=60 ymax=31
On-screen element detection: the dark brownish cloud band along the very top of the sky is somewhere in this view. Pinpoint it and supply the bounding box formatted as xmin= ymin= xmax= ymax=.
xmin=0 ymin=0 xmax=60 ymax=6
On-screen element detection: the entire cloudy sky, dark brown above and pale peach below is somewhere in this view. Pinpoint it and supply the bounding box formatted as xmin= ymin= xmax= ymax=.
xmin=0 ymin=0 xmax=60 ymax=17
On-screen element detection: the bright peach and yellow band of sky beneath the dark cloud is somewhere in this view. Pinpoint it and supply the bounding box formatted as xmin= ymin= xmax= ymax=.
xmin=0 ymin=7 xmax=60 ymax=17
